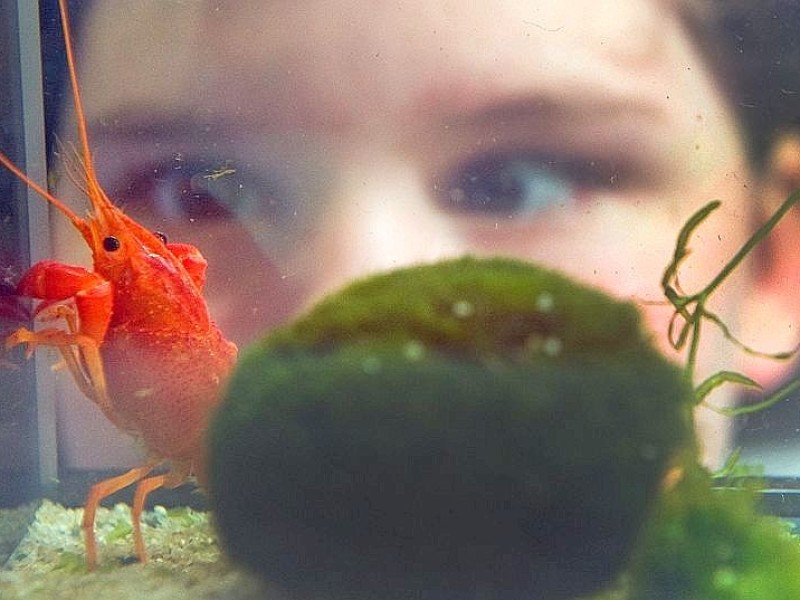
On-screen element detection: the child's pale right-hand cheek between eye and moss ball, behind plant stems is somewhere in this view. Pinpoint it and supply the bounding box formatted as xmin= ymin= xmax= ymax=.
xmin=460 ymin=199 xmax=749 ymax=371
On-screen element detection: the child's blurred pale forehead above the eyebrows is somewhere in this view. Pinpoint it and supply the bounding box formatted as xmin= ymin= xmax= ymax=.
xmin=80 ymin=0 xmax=690 ymax=132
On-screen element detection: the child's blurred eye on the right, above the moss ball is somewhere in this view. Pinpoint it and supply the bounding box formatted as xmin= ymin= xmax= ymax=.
xmin=437 ymin=153 xmax=617 ymax=216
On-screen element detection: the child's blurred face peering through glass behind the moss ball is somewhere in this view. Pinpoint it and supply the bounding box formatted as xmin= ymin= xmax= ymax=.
xmin=54 ymin=0 xmax=764 ymax=460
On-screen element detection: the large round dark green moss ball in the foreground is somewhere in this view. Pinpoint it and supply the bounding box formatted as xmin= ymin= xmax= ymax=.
xmin=210 ymin=258 xmax=692 ymax=600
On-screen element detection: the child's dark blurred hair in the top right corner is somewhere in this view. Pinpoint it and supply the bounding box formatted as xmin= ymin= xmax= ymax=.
xmin=680 ymin=0 xmax=800 ymax=168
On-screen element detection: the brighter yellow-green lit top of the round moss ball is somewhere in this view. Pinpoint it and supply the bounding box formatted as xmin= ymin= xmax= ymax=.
xmin=263 ymin=257 xmax=649 ymax=358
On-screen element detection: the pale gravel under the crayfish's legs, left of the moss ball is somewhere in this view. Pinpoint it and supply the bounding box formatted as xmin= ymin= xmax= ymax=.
xmin=0 ymin=500 xmax=272 ymax=600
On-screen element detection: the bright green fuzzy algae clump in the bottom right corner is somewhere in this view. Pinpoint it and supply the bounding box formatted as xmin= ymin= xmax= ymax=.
xmin=627 ymin=464 xmax=800 ymax=600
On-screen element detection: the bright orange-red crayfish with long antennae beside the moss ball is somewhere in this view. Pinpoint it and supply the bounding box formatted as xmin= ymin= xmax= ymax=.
xmin=0 ymin=0 xmax=237 ymax=569
